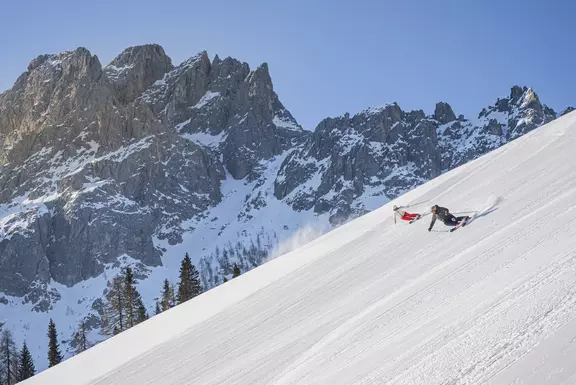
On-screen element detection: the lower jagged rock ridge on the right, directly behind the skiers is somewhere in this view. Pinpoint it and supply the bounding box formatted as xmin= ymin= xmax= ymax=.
xmin=274 ymin=87 xmax=556 ymax=224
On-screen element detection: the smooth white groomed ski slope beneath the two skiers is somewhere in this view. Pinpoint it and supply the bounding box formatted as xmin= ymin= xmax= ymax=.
xmin=25 ymin=113 xmax=576 ymax=385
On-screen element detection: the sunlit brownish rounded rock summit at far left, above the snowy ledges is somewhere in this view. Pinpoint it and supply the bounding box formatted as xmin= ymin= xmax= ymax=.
xmin=0 ymin=48 xmax=113 ymax=158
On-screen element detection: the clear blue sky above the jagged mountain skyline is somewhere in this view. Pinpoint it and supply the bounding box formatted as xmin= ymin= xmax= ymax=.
xmin=0 ymin=0 xmax=576 ymax=129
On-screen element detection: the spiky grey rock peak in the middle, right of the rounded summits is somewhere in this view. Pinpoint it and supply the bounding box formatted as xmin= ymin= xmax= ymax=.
xmin=142 ymin=52 xmax=304 ymax=179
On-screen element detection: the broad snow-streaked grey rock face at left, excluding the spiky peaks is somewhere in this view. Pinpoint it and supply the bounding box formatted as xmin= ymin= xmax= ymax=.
xmin=0 ymin=46 xmax=224 ymax=296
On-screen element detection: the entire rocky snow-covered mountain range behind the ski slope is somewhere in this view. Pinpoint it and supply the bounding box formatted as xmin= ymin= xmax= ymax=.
xmin=0 ymin=45 xmax=572 ymax=368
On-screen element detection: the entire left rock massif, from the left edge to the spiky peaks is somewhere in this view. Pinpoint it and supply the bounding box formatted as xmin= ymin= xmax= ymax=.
xmin=0 ymin=46 xmax=294 ymax=298
